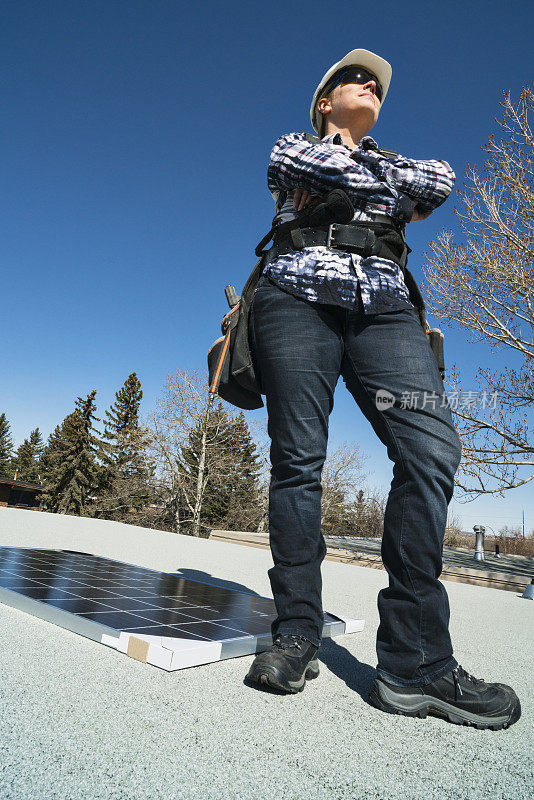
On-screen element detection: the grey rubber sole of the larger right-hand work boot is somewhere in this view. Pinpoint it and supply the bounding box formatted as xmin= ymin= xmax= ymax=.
xmin=369 ymin=680 xmax=521 ymax=731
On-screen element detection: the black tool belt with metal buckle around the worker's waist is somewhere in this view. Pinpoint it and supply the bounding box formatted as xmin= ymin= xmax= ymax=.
xmin=269 ymin=222 xmax=411 ymax=270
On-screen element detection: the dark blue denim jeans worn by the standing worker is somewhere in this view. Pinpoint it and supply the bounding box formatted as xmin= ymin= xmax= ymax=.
xmin=248 ymin=274 xmax=461 ymax=686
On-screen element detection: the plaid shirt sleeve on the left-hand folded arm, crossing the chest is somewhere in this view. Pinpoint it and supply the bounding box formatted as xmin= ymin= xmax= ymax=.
xmin=267 ymin=133 xmax=384 ymax=206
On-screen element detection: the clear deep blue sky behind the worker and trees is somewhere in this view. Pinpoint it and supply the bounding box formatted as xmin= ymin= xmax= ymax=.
xmin=0 ymin=0 xmax=534 ymax=531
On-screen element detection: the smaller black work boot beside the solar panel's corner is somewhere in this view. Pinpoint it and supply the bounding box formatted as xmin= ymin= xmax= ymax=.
xmin=246 ymin=633 xmax=319 ymax=694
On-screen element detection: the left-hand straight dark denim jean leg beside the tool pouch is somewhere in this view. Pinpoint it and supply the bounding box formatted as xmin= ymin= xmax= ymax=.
xmin=249 ymin=281 xmax=343 ymax=647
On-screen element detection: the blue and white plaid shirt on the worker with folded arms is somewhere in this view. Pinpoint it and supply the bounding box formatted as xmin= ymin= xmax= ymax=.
xmin=264 ymin=132 xmax=455 ymax=314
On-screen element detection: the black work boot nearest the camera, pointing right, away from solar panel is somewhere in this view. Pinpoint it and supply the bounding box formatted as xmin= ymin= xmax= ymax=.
xmin=369 ymin=664 xmax=521 ymax=731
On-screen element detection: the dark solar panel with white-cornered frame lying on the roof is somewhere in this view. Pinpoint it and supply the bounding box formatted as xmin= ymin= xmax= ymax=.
xmin=0 ymin=547 xmax=364 ymax=670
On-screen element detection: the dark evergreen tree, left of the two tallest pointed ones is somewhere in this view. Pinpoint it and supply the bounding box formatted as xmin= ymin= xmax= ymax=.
xmin=42 ymin=389 xmax=100 ymax=516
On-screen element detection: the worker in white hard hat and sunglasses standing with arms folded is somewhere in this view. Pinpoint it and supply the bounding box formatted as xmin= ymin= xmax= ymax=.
xmin=247 ymin=49 xmax=520 ymax=729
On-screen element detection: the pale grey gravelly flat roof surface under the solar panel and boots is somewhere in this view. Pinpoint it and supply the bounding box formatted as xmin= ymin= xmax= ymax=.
xmin=0 ymin=508 xmax=534 ymax=800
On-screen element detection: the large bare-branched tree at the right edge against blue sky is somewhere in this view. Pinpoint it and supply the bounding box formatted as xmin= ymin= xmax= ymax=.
xmin=423 ymin=87 xmax=534 ymax=497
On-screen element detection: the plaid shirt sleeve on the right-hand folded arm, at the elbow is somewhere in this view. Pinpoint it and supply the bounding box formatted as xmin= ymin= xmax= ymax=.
xmin=386 ymin=156 xmax=456 ymax=212
